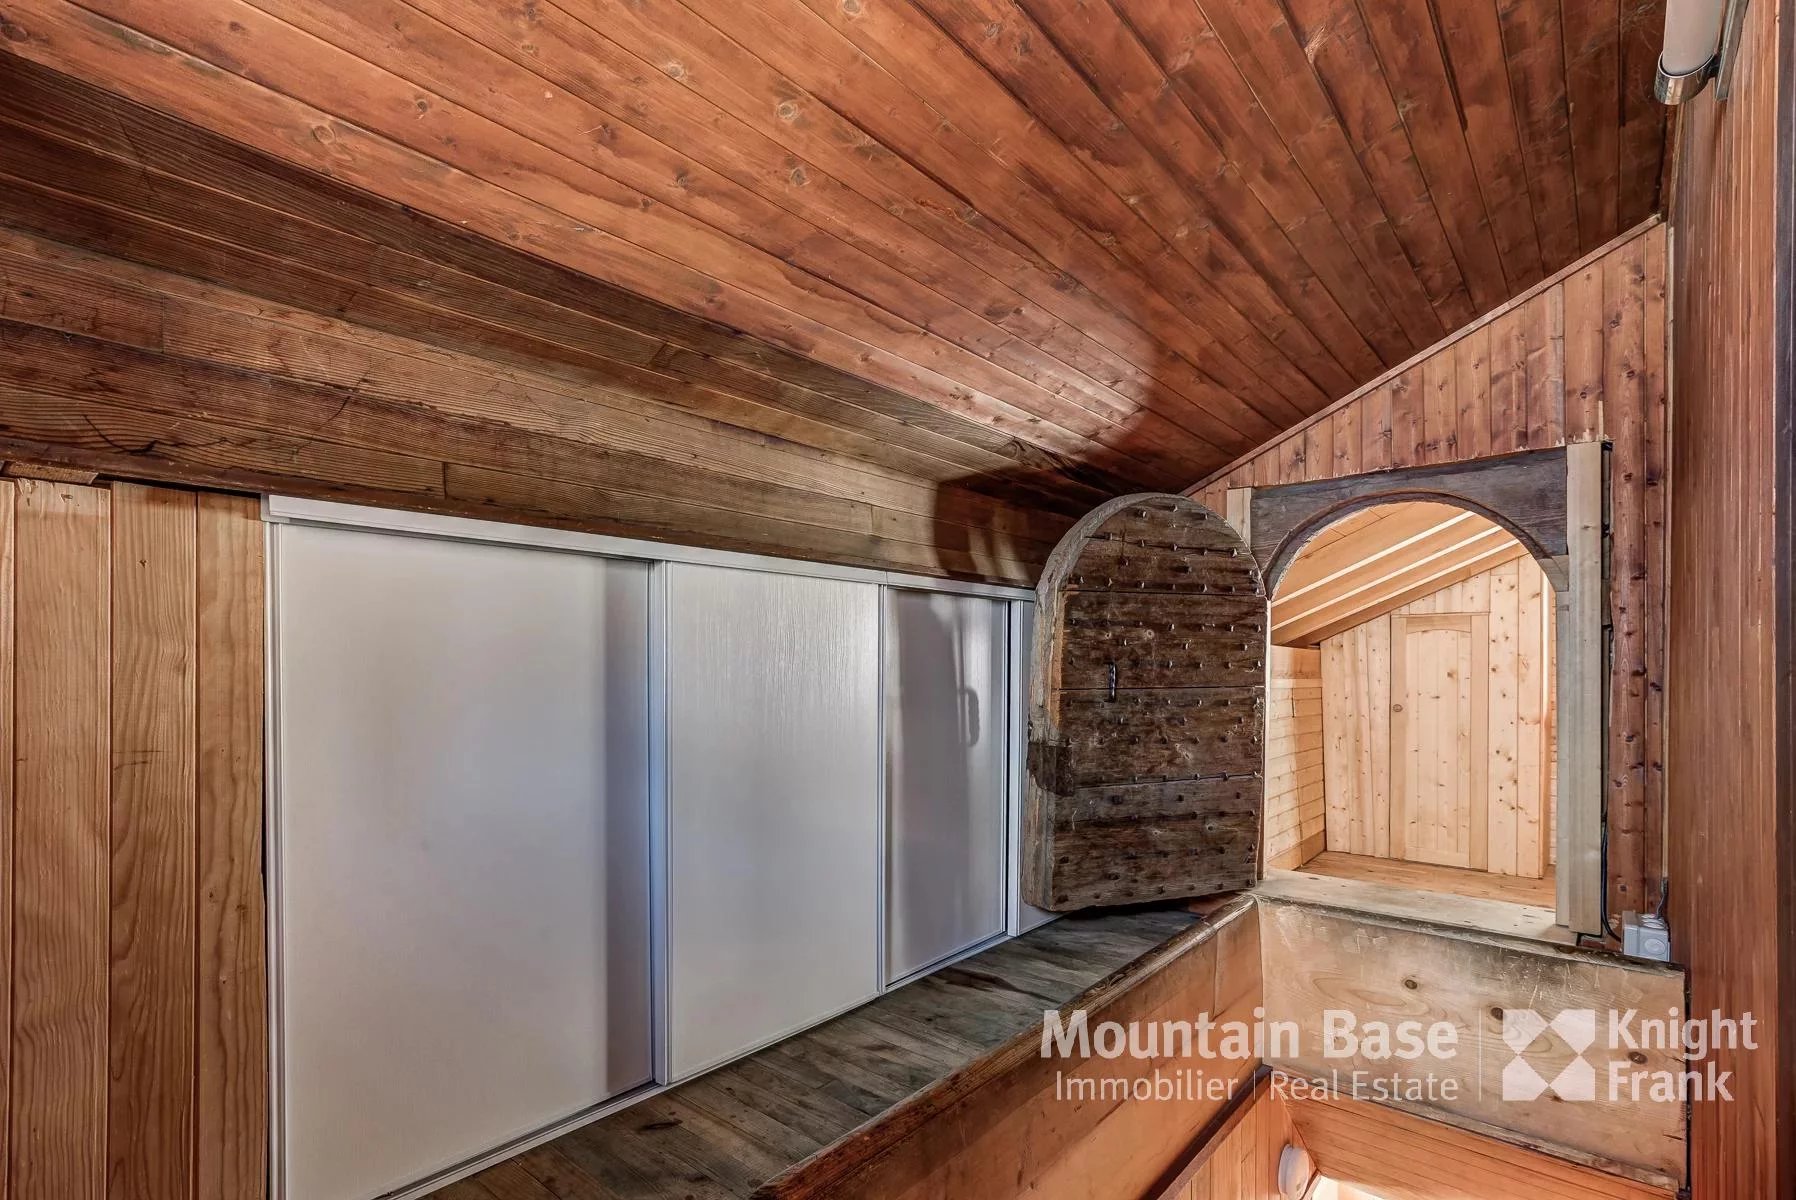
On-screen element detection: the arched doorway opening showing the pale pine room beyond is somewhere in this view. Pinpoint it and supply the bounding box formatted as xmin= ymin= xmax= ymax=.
xmin=1263 ymin=496 xmax=1559 ymax=911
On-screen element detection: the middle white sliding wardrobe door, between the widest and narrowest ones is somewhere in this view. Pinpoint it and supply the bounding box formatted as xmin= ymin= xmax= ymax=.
xmin=666 ymin=564 xmax=880 ymax=1078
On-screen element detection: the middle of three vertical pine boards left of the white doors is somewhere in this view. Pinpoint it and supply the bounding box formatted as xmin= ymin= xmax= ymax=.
xmin=106 ymin=483 xmax=196 ymax=1200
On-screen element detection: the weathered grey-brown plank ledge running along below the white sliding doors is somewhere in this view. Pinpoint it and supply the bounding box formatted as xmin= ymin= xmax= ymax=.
xmin=433 ymin=909 xmax=1198 ymax=1200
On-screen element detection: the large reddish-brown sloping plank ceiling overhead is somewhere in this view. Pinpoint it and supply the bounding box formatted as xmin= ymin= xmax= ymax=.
xmin=0 ymin=0 xmax=1665 ymax=507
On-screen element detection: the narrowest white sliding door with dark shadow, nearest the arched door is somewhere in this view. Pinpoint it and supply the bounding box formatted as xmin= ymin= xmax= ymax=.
xmin=885 ymin=587 xmax=1009 ymax=979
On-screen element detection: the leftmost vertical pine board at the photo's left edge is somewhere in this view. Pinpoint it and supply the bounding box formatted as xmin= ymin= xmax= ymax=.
xmin=11 ymin=480 xmax=111 ymax=1200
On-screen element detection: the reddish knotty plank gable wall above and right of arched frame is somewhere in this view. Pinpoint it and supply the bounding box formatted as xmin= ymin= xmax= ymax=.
xmin=1193 ymin=223 xmax=1668 ymax=920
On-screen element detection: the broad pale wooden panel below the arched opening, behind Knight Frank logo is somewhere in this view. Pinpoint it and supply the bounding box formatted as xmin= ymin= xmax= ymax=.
xmin=1259 ymin=900 xmax=1685 ymax=1191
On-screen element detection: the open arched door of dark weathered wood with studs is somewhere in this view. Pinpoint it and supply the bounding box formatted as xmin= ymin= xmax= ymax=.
xmin=1024 ymin=494 xmax=1268 ymax=911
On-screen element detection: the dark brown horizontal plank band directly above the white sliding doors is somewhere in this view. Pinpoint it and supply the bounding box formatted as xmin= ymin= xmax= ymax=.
xmin=0 ymin=226 xmax=1070 ymax=582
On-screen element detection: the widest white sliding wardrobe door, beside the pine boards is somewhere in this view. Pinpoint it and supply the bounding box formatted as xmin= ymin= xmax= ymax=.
xmin=275 ymin=526 xmax=652 ymax=1200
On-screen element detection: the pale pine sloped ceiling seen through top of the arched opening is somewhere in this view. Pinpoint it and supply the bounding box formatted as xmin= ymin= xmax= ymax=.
xmin=1272 ymin=501 xmax=1528 ymax=647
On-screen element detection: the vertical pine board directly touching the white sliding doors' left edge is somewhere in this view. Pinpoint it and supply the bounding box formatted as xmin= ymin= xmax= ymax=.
xmin=194 ymin=494 xmax=268 ymax=1200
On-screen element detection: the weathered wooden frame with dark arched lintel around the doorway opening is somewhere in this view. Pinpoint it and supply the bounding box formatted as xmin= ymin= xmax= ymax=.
xmin=1228 ymin=442 xmax=1609 ymax=934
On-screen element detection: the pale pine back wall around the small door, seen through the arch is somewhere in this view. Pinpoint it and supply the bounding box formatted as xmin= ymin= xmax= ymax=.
xmin=1320 ymin=555 xmax=1554 ymax=878
